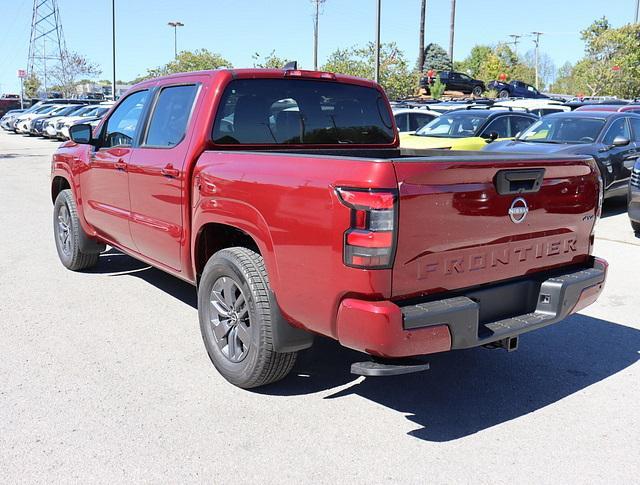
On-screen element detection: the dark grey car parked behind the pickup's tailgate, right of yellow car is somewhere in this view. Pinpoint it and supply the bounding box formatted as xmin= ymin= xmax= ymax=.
xmin=484 ymin=111 xmax=640 ymax=197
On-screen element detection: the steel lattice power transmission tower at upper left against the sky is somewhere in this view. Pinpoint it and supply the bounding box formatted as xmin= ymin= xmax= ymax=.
xmin=27 ymin=0 xmax=66 ymax=95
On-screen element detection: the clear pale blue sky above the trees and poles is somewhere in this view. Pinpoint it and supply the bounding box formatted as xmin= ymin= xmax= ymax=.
xmin=0 ymin=0 xmax=635 ymax=92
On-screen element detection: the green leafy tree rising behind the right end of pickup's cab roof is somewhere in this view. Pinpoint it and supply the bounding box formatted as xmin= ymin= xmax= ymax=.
xmin=322 ymin=42 xmax=419 ymax=98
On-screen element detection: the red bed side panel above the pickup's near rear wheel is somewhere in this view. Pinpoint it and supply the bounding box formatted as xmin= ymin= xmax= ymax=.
xmin=192 ymin=151 xmax=396 ymax=337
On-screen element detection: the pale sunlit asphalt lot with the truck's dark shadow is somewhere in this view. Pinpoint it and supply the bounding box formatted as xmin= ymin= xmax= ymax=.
xmin=0 ymin=132 xmax=640 ymax=484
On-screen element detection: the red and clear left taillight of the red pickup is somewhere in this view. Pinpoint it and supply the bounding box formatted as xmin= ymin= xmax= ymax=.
xmin=336 ymin=188 xmax=398 ymax=269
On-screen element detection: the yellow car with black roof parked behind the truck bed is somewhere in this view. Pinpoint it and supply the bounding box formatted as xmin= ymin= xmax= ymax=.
xmin=400 ymin=106 xmax=538 ymax=150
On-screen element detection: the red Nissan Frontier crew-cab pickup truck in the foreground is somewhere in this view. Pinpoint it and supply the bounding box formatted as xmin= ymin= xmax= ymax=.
xmin=51 ymin=69 xmax=607 ymax=388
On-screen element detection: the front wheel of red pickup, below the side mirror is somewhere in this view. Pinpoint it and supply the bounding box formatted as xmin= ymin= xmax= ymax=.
xmin=53 ymin=189 xmax=100 ymax=271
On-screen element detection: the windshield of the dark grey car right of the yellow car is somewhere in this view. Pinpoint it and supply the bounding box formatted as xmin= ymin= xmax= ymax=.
xmin=517 ymin=116 xmax=606 ymax=143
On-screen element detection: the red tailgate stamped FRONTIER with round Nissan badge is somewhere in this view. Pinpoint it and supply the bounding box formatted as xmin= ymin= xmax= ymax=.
xmin=393 ymin=155 xmax=599 ymax=298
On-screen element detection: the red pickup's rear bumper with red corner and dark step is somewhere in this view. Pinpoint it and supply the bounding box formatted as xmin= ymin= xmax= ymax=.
xmin=337 ymin=258 xmax=607 ymax=357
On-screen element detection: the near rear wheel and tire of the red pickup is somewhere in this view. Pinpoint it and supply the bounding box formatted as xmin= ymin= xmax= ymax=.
xmin=198 ymin=247 xmax=297 ymax=389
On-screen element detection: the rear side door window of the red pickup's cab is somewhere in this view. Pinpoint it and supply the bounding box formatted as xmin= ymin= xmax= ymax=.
xmin=145 ymin=84 xmax=197 ymax=148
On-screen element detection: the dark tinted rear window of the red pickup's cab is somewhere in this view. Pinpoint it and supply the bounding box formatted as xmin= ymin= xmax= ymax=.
xmin=213 ymin=79 xmax=395 ymax=145
